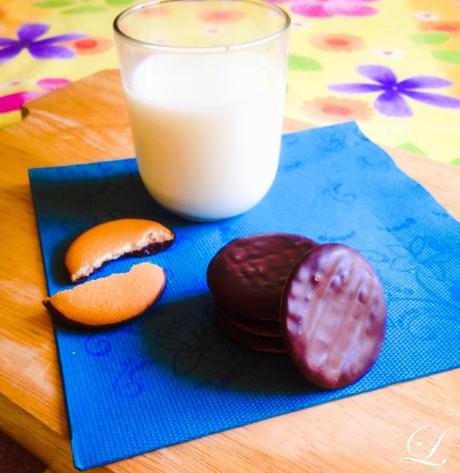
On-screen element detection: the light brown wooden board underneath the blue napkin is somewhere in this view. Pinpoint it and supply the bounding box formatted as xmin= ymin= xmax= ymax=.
xmin=0 ymin=71 xmax=460 ymax=473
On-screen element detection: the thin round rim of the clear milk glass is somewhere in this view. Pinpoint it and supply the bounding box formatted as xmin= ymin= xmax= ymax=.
xmin=113 ymin=0 xmax=291 ymax=53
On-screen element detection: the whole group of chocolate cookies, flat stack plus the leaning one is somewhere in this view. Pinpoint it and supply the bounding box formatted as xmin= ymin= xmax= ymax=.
xmin=208 ymin=233 xmax=386 ymax=389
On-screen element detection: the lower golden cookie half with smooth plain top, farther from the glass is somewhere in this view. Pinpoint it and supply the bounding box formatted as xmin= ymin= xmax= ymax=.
xmin=43 ymin=263 xmax=166 ymax=327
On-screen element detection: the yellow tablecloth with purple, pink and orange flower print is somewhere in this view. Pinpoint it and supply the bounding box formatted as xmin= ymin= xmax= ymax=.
xmin=0 ymin=0 xmax=460 ymax=165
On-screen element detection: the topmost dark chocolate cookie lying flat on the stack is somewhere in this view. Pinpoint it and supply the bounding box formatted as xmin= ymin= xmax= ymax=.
xmin=208 ymin=233 xmax=316 ymax=320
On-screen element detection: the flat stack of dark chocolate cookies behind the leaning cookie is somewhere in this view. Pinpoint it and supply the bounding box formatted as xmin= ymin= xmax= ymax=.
xmin=208 ymin=233 xmax=316 ymax=353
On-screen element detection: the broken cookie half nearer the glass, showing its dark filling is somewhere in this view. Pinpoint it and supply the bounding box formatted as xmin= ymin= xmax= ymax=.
xmin=65 ymin=218 xmax=174 ymax=282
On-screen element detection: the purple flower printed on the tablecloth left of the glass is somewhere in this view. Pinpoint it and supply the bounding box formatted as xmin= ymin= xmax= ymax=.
xmin=0 ymin=23 xmax=85 ymax=63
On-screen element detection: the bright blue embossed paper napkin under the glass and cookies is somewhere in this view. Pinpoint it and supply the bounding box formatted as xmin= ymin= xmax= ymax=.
xmin=30 ymin=123 xmax=460 ymax=470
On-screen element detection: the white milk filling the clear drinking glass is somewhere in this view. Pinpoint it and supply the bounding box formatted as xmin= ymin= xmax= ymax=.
xmin=125 ymin=52 xmax=284 ymax=220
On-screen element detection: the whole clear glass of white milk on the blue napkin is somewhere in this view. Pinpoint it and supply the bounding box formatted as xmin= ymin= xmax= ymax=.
xmin=114 ymin=0 xmax=290 ymax=220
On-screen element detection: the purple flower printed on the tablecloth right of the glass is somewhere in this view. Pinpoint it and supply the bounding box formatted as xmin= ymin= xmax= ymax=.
xmin=329 ymin=65 xmax=460 ymax=117
